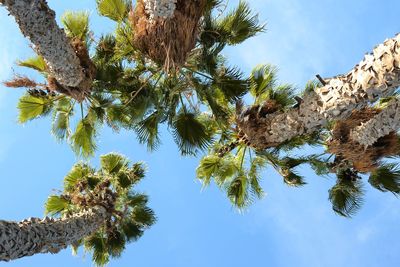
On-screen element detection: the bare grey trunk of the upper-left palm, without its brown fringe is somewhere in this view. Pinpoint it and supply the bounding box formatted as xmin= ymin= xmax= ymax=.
xmin=0 ymin=0 xmax=85 ymax=87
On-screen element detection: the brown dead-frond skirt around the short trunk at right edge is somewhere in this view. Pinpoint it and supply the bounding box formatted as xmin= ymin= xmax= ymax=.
xmin=328 ymin=108 xmax=400 ymax=173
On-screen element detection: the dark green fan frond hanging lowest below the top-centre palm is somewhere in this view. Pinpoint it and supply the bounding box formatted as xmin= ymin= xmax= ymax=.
xmin=171 ymin=110 xmax=212 ymax=155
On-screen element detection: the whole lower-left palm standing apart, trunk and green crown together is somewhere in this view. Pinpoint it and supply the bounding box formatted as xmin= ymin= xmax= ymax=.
xmin=0 ymin=153 xmax=156 ymax=266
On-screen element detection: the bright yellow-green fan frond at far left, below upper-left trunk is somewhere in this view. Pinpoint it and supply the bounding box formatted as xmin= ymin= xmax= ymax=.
xmin=17 ymin=94 xmax=53 ymax=123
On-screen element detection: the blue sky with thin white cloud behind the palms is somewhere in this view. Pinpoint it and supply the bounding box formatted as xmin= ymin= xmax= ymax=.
xmin=0 ymin=0 xmax=400 ymax=267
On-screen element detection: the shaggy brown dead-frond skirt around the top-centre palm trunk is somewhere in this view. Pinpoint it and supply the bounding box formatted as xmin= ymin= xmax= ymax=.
xmin=129 ymin=0 xmax=207 ymax=71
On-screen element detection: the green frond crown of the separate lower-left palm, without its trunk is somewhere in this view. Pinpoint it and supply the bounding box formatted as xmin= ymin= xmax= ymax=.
xmin=46 ymin=153 xmax=156 ymax=266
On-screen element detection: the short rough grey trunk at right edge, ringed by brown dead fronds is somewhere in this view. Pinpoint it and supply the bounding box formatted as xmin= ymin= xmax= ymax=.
xmin=350 ymin=100 xmax=400 ymax=147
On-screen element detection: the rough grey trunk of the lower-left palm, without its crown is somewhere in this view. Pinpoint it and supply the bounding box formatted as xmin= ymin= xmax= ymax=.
xmin=0 ymin=207 xmax=107 ymax=261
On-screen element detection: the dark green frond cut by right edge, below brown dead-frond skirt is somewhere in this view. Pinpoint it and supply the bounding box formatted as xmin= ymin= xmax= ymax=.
xmin=368 ymin=164 xmax=400 ymax=195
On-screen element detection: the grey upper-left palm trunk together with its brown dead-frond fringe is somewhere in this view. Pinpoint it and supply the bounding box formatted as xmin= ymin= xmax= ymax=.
xmin=1 ymin=0 xmax=94 ymax=101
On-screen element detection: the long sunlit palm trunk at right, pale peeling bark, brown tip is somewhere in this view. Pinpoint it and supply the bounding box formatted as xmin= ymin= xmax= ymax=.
xmin=238 ymin=35 xmax=400 ymax=148
